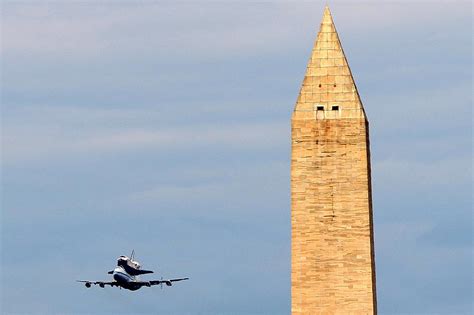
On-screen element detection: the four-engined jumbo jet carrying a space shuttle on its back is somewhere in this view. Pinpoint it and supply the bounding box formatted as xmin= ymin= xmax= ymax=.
xmin=77 ymin=251 xmax=189 ymax=291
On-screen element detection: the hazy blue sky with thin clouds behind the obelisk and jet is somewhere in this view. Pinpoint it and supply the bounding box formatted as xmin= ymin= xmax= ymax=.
xmin=0 ymin=0 xmax=473 ymax=315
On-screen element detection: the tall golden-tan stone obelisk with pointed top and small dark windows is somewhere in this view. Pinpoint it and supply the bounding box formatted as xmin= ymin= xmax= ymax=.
xmin=291 ymin=7 xmax=377 ymax=315
